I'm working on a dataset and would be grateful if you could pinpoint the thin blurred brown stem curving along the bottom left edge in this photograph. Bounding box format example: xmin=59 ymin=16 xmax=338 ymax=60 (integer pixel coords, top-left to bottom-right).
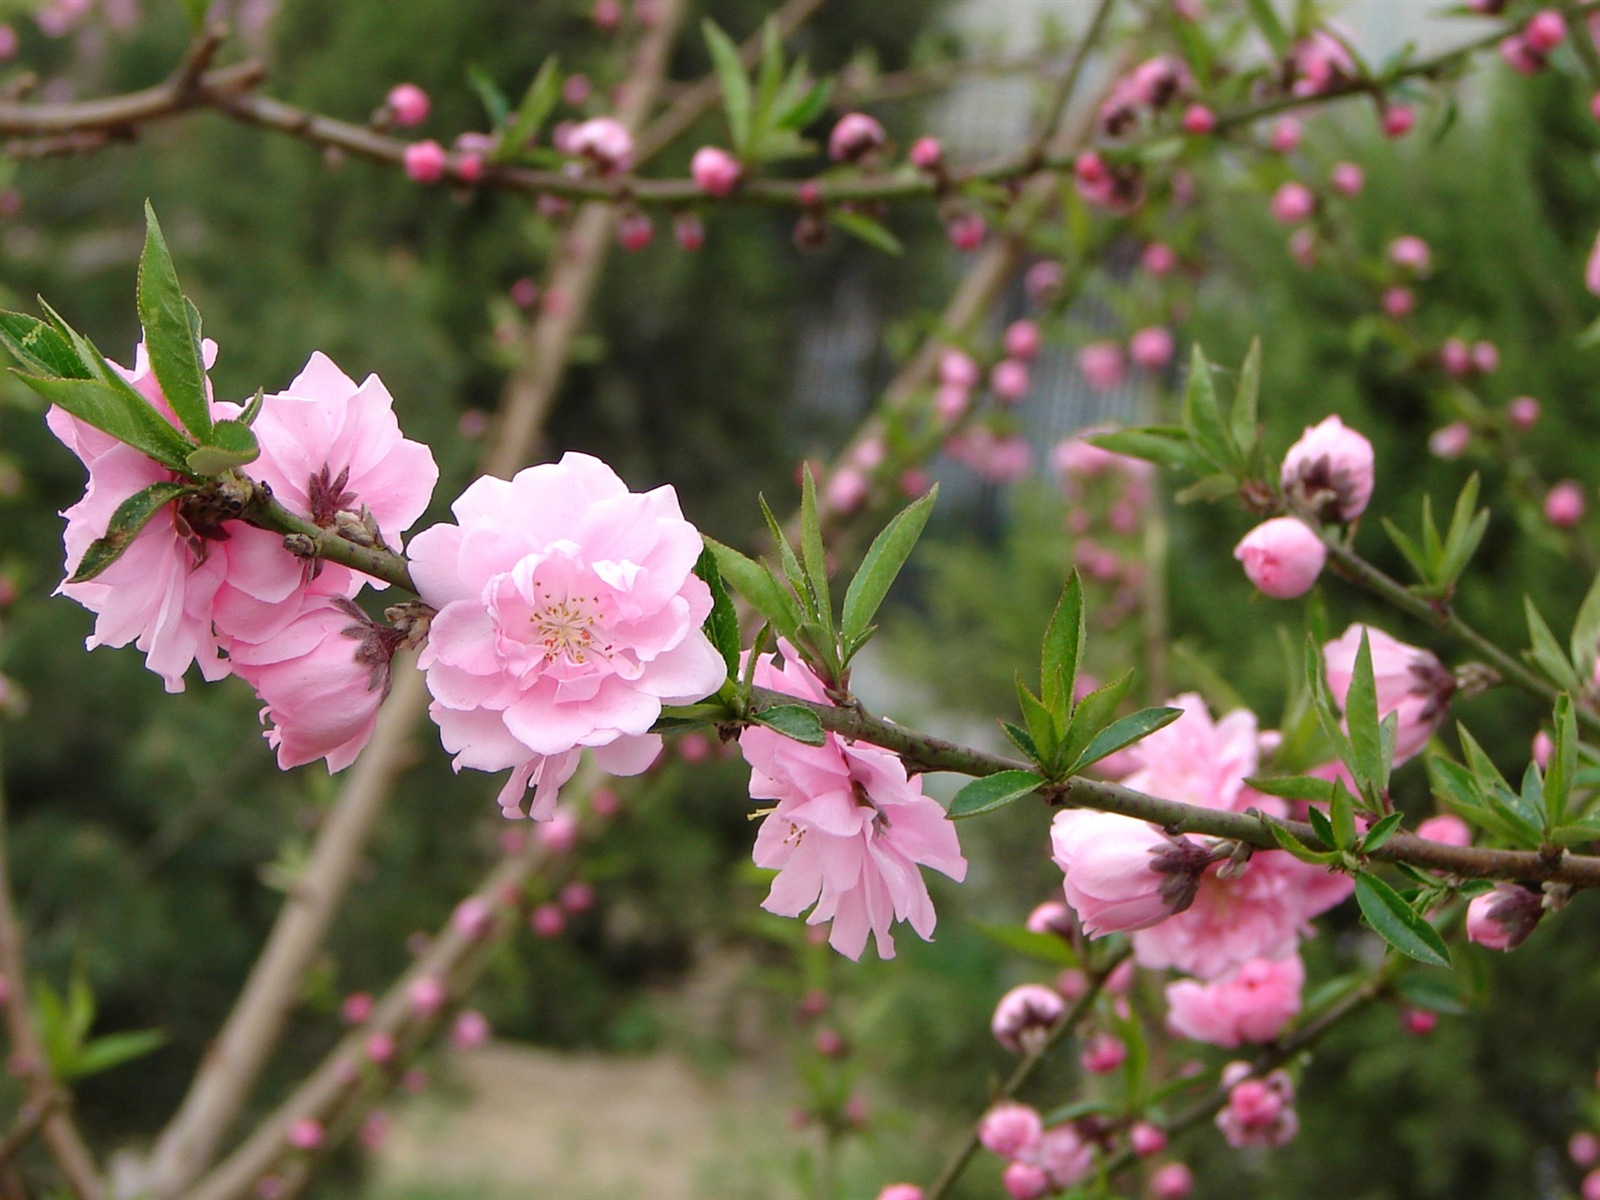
xmin=0 ymin=739 xmax=106 ymax=1200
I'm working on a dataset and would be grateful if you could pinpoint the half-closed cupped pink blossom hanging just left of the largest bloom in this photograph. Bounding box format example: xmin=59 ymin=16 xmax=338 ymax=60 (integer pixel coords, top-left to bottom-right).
xmin=229 ymin=595 xmax=402 ymax=771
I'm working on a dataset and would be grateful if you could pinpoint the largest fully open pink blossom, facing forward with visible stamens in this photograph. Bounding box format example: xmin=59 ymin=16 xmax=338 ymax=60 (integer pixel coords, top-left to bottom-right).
xmin=411 ymin=453 xmax=726 ymax=819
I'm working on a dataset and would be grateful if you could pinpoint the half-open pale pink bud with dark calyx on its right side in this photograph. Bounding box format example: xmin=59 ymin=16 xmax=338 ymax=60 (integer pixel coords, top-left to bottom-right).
xmin=1050 ymin=808 xmax=1211 ymax=938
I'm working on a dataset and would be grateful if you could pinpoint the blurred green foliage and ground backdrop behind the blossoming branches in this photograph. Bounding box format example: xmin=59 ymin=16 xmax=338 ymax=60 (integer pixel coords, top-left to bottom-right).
xmin=0 ymin=0 xmax=1600 ymax=1200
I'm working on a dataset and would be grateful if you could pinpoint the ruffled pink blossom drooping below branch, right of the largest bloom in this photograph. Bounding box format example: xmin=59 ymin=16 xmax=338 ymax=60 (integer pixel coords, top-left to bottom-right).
xmin=739 ymin=650 xmax=966 ymax=958
